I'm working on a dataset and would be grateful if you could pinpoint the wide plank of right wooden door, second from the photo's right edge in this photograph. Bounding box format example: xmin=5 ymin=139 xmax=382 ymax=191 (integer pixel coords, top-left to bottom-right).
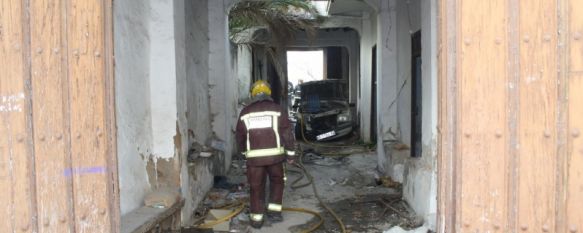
xmin=512 ymin=0 xmax=559 ymax=232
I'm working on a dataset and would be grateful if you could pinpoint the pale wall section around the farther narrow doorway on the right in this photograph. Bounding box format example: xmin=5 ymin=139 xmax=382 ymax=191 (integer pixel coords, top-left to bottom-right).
xmin=359 ymin=0 xmax=398 ymax=147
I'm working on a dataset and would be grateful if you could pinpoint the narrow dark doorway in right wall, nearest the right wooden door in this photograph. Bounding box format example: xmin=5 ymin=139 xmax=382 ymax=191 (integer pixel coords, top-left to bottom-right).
xmin=411 ymin=31 xmax=422 ymax=157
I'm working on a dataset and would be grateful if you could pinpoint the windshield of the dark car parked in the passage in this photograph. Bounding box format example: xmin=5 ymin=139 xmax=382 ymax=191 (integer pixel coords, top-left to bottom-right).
xmin=301 ymin=81 xmax=348 ymax=101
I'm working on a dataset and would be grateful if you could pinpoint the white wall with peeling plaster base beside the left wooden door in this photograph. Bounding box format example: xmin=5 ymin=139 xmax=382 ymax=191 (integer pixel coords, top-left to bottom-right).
xmin=114 ymin=0 xmax=185 ymax=215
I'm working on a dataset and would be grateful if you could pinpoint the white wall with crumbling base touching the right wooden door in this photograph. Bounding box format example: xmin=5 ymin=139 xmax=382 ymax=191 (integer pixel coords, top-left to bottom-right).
xmin=388 ymin=0 xmax=437 ymax=230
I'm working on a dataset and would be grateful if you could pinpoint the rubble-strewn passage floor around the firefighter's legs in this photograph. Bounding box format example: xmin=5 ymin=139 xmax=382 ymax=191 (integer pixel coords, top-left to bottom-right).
xmin=183 ymin=145 xmax=423 ymax=233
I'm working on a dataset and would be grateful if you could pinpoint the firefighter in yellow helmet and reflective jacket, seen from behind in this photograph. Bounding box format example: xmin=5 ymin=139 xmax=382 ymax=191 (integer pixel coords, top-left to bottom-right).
xmin=236 ymin=80 xmax=295 ymax=228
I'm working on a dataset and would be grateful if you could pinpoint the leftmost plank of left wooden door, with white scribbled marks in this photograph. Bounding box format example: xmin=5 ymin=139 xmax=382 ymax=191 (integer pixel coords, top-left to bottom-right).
xmin=0 ymin=0 xmax=37 ymax=232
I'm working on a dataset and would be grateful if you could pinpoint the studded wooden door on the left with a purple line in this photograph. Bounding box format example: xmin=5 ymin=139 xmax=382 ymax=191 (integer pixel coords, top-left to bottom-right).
xmin=0 ymin=0 xmax=119 ymax=233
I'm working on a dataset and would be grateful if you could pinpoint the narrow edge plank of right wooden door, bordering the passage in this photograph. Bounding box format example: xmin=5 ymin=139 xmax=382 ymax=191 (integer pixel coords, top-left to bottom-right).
xmin=437 ymin=0 xmax=459 ymax=232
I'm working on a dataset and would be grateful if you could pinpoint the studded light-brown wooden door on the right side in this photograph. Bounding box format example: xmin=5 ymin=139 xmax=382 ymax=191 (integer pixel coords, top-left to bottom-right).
xmin=438 ymin=0 xmax=583 ymax=232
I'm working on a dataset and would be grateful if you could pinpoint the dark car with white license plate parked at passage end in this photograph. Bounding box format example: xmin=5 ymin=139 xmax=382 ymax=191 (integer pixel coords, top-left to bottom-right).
xmin=294 ymin=80 xmax=354 ymax=141
